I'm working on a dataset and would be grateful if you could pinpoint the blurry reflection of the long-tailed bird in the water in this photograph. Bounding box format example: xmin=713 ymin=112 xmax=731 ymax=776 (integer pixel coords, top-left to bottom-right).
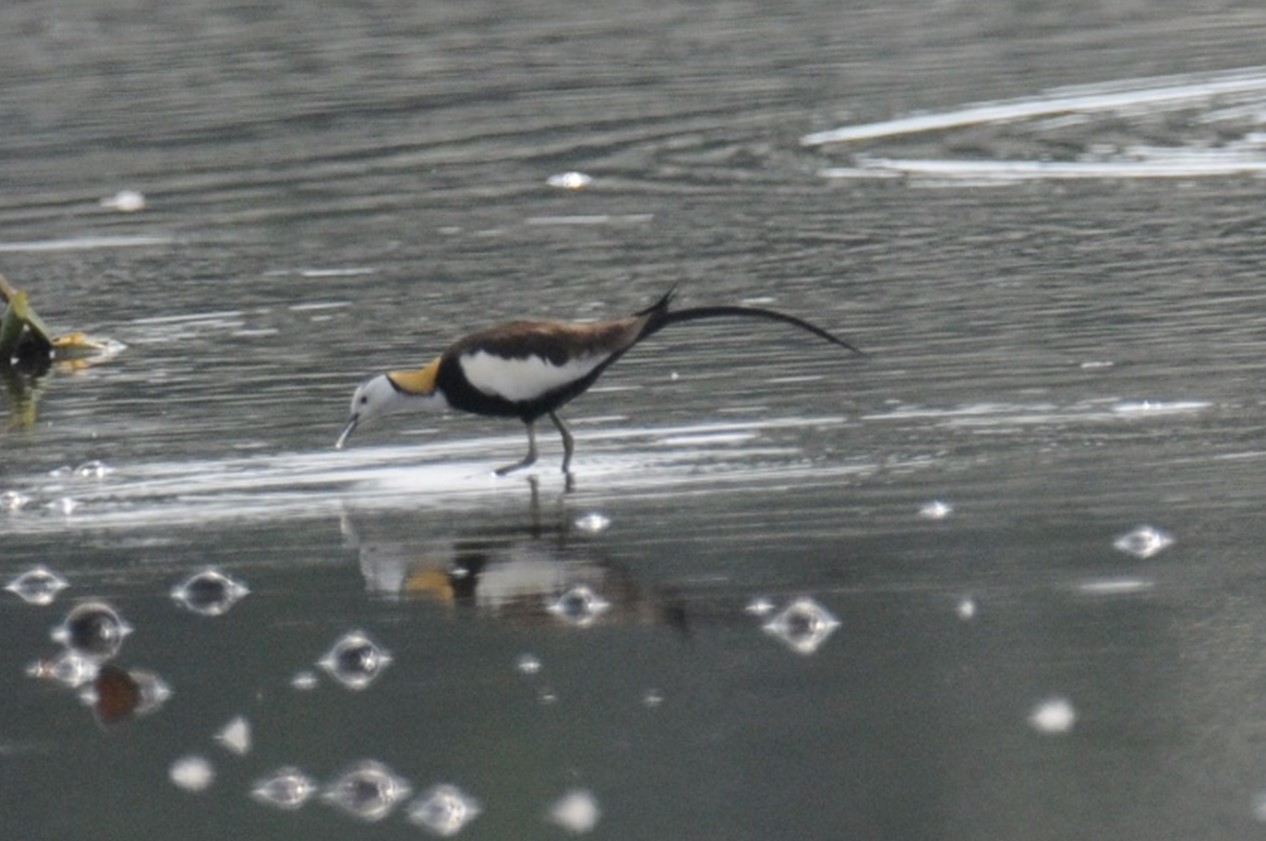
xmin=342 ymin=480 xmax=685 ymax=627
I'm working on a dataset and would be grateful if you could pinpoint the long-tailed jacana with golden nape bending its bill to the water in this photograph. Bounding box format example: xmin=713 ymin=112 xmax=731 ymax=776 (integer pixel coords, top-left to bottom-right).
xmin=334 ymin=290 xmax=861 ymax=476
